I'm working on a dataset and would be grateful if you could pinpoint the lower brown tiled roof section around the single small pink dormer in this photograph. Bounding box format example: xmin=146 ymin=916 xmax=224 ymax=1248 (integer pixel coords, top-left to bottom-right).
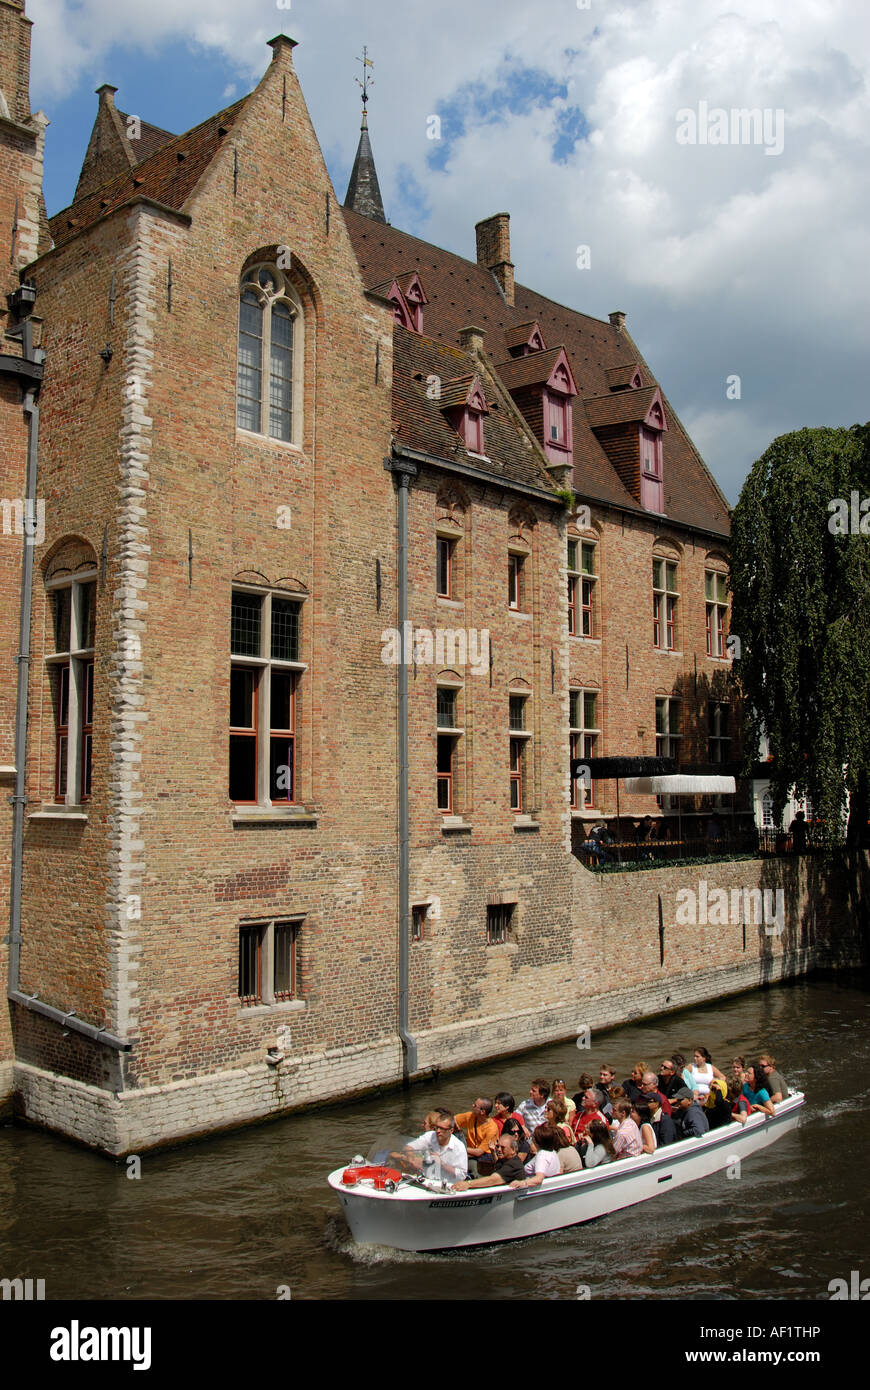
xmin=393 ymin=324 xmax=553 ymax=492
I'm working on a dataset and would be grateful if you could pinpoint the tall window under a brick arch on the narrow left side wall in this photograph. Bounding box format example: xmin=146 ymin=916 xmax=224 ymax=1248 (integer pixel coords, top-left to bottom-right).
xmin=46 ymin=569 xmax=97 ymax=806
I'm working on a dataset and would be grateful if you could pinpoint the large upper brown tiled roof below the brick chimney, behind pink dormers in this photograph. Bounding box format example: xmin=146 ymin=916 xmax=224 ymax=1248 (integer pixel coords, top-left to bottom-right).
xmin=345 ymin=209 xmax=730 ymax=537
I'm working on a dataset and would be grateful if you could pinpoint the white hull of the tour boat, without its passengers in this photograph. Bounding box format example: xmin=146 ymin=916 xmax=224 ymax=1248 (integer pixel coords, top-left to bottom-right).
xmin=329 ymin=1091 xmax=805 ymax=1251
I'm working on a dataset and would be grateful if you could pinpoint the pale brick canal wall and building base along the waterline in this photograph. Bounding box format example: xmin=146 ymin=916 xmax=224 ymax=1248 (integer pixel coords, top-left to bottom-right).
xmin=6 ymin=856 xmax=870 ymax=1155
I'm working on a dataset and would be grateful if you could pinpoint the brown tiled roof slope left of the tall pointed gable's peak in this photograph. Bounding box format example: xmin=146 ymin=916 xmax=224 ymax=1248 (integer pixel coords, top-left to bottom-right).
xmin=50 ymin=96 xmax=247 ymax=246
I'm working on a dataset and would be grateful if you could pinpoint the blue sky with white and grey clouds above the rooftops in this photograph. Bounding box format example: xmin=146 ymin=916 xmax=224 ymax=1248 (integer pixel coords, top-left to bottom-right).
xmin=28 ymin=0 xmax=870 ymax=502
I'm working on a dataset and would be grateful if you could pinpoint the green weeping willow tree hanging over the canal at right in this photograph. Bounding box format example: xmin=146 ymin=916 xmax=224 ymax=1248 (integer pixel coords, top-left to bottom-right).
xmin=731 ymin=425 xmax=870 ymax=842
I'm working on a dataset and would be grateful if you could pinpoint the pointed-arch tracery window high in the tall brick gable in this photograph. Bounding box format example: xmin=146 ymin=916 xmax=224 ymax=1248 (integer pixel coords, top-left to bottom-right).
xmin=236 ymin=265 xmax=304 ymax=446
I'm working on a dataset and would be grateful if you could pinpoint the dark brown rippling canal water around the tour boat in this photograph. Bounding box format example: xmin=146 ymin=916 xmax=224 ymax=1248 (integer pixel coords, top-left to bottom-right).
xmin=0 ymin=974 xmax=870 ymax=1300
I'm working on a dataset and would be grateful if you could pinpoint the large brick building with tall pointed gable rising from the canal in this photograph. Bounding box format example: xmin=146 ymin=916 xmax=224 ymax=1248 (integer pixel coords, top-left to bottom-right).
xmin=0 ymin=8 xmax=750 ymax=1152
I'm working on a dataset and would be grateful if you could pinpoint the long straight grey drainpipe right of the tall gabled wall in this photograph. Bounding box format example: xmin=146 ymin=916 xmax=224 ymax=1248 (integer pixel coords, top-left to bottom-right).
xmin=384 ymin=459 xmax=420 ymax=1086
